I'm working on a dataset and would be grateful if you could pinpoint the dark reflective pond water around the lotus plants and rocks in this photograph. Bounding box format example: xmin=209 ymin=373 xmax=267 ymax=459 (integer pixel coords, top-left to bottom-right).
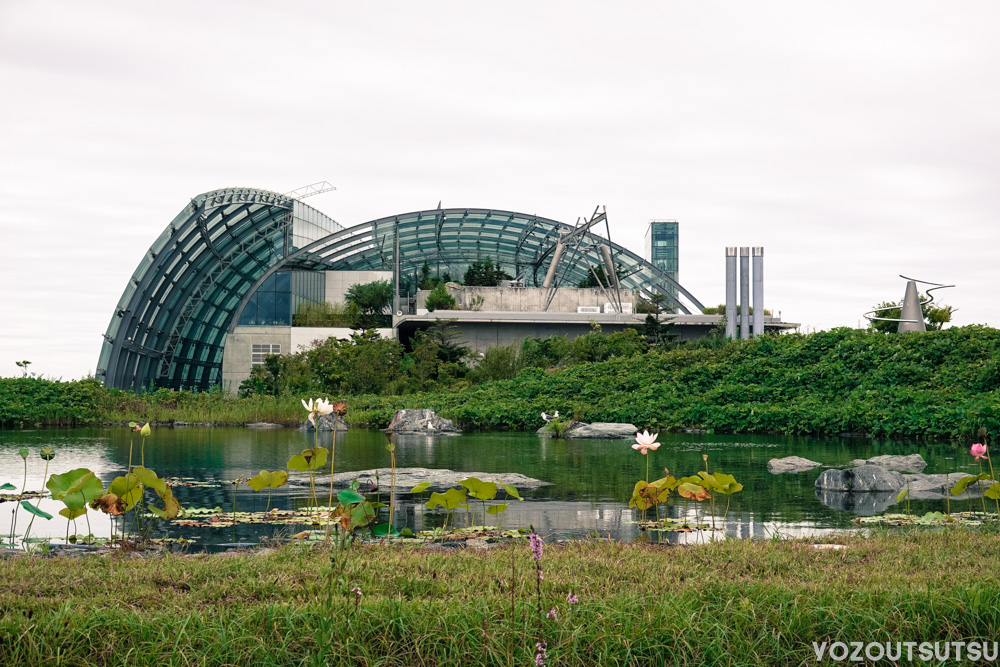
xmin=0 ymin=427 xmax=979 ymax=549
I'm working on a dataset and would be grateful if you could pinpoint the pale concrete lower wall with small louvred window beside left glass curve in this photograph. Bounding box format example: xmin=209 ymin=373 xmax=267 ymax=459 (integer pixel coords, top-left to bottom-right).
xmin=222 ymin=326 xmax=396 ymax=394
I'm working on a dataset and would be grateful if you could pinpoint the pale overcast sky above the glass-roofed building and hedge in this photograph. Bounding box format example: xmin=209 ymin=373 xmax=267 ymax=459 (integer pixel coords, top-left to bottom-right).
xmin=0 ymin=0 xmax=1000 ymax=379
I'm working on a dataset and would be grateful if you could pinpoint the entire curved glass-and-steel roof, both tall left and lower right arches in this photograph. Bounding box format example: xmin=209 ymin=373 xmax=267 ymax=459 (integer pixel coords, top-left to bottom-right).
xmin=97 ymin=188 xmax=702 ymax=391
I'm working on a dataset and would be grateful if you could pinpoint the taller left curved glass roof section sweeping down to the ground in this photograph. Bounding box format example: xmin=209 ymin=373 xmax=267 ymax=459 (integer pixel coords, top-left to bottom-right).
xmin=97 ymin=188 xmax=342 ymax=391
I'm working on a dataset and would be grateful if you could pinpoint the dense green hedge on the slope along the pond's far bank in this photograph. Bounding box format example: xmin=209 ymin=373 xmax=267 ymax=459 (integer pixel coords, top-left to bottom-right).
xmin=0 ymin=326 xmax=1000 ymax=437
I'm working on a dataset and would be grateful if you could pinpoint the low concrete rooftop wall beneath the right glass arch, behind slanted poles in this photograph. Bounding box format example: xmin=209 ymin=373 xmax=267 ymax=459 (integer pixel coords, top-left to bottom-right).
xmin=416 ymin=287 xmax=638 ymax=313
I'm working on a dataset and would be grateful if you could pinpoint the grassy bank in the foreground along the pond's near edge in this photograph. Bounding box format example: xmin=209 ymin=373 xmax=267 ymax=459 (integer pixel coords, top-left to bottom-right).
xmin=0 ymin=529 xmax=1000 ymax=666
